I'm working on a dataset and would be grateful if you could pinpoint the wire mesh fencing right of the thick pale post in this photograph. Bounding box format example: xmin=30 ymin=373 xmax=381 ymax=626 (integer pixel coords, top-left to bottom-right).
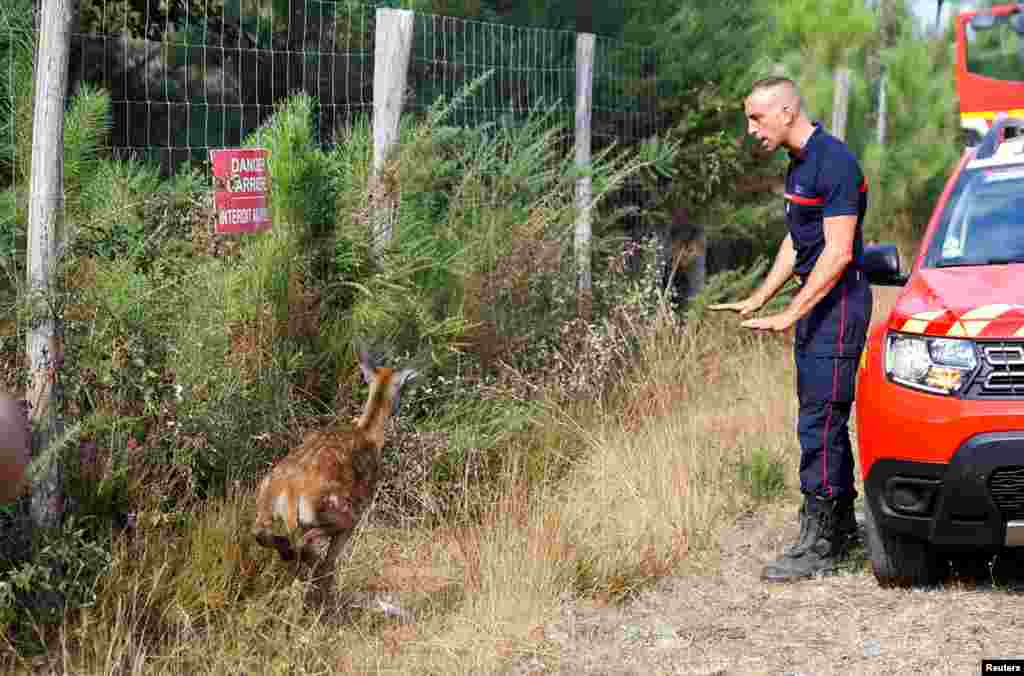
xmin=407 ymin=14 xmax=657 ymax=237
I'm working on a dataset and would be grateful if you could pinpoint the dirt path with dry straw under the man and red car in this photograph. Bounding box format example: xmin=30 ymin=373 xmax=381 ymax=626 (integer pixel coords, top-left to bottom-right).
xmin=512 ymin=505 xmax=1024 ymax=676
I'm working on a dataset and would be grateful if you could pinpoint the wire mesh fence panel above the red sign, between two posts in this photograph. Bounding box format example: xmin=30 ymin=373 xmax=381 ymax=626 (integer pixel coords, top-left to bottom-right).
xmin=71 ymin=0 xmax=374 ymax=170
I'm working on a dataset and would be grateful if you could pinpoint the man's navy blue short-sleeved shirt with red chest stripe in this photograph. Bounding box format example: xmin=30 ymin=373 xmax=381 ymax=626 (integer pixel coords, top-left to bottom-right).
xmin=785 ymin=123 xmax=867 ymax=277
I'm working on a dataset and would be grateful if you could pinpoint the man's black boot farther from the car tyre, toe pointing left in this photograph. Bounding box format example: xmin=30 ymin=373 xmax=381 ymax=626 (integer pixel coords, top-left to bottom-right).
xmin=761 ymin=496 xmax=843 ymax=582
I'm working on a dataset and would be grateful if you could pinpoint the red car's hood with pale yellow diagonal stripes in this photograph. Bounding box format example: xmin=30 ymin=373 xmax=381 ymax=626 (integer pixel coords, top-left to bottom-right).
xmin=889 ymin=264 xmax=1024 ymax=338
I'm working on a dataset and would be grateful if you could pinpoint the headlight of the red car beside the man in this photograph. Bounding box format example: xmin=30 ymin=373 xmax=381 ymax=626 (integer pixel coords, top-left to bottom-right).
xmin=886 ymin=333 xmax=978 ymax=394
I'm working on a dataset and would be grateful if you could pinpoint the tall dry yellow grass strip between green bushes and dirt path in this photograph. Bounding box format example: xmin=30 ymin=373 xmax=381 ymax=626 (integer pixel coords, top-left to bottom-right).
xmin=14 ymin=318 xmax=796 ymax=676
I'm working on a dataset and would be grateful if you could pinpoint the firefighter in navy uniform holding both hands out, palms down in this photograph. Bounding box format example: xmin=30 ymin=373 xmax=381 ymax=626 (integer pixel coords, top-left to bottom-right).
xmin=711 ymin=77 xmax=871 ymax=582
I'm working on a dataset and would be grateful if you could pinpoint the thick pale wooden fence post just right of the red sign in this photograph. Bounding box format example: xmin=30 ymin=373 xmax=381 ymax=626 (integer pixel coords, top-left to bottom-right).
xmin=370 ymin=8 xmax=414 ymax=257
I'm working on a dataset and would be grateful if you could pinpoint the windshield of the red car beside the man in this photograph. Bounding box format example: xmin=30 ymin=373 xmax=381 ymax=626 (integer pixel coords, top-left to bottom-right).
xmin=930 ymin=165 xmax=1024 ymax=267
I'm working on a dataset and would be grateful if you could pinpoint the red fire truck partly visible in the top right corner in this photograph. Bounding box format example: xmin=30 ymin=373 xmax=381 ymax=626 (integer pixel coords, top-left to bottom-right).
xmin=956 ymin=3 xmax=1024 ymax=145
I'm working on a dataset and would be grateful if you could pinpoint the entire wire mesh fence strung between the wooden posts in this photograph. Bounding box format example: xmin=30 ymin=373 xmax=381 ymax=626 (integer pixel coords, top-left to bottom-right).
xmin=0 ymin=0 xmax=657 ymax=229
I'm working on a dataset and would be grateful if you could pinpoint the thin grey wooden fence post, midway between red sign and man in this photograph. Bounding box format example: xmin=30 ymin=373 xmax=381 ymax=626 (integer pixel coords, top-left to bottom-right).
xmin=573 ymin=33 xmax=595 ymax=320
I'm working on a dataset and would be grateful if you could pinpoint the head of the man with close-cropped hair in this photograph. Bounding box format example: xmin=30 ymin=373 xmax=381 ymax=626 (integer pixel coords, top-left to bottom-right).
xmin=743 ymin=77 xmax=809 ymax=153
